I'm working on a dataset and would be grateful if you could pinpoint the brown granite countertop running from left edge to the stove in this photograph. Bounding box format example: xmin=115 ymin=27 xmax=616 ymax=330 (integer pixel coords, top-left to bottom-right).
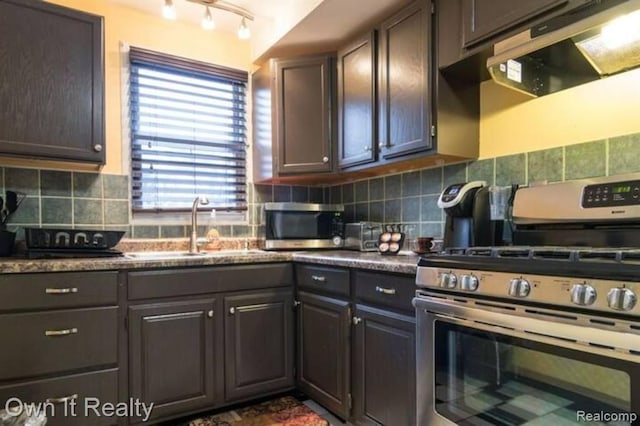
xmin=0 ymin=250 xmax=418 ymax=275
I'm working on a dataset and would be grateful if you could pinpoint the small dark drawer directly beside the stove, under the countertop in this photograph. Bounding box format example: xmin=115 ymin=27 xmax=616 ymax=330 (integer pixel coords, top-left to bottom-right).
xmin=354 ymin=271 xmax=416 ymax=311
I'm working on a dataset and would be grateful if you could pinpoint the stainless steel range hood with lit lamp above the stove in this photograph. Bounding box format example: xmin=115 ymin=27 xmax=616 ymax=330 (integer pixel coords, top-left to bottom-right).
xmin=487 ymin=0 xmax=640 ymax=96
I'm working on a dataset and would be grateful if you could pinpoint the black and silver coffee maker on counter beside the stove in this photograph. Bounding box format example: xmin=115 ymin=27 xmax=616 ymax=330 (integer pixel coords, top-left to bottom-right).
xmin=438 ymin=181 xmax=505 ymax=249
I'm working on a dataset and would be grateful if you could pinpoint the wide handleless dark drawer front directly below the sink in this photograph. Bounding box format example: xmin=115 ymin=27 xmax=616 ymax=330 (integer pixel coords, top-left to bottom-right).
xmin=128 ymin=263 xmax=293 ymax=300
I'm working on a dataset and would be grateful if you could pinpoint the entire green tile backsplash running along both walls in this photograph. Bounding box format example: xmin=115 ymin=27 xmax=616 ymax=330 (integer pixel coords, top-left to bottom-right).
xmin=0 ymin=130 xmax=640 ymax=243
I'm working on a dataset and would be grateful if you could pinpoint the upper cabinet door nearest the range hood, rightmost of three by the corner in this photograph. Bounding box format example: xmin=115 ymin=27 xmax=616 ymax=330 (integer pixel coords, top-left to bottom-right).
xmin=378 ymin=0 xmax=432 ymax=158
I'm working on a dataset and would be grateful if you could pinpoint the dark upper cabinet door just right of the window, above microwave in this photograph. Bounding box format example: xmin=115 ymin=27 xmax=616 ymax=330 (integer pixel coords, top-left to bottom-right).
xmin=275 ymin=56 xmax=333 ymax=174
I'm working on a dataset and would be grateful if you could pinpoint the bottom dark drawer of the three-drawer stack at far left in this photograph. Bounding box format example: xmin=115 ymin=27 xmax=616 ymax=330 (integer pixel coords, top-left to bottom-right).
xmin=0 ymin=369 xmax=118 ymax=426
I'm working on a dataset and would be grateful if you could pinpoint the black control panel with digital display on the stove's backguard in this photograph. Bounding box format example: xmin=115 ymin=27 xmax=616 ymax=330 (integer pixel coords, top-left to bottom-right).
xmin=582 ymin=180 xmax=640 ymax=208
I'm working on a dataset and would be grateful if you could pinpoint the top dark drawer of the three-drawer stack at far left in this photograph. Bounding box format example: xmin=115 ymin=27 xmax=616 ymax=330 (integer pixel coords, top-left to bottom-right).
xmin=0 ymin=271 xmax=118 ymax=311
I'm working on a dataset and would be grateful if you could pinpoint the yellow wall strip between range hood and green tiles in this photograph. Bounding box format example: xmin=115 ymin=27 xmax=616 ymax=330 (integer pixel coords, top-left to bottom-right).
xmin=480 ymin=69 xmax=640 ymax=158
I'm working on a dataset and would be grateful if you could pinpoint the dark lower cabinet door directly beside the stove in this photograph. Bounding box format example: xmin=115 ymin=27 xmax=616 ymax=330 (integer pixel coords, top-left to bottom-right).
xmin=353 ymin=305 xmax=416 ymax=426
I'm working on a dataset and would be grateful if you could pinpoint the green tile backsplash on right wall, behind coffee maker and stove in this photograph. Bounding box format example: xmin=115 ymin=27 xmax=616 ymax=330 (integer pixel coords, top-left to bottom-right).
xmin=327 ymin=134 xmax=640 ymax=236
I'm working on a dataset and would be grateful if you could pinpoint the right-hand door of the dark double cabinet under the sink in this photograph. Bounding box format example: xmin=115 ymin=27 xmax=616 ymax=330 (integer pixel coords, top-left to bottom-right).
xmin=224 ymin=290 xmax=294 ymax=401
